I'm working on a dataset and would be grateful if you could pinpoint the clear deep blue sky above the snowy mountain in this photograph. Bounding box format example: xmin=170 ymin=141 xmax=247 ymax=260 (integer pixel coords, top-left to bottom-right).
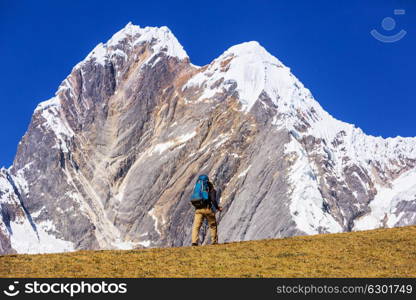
xmin=0 ymin=0 xmax=416 ymax=167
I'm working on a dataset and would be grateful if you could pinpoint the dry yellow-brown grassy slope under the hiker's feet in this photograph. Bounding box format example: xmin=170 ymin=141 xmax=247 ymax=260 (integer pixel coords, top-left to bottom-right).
xmin=0 ymin=226 xmax=416 ymax=277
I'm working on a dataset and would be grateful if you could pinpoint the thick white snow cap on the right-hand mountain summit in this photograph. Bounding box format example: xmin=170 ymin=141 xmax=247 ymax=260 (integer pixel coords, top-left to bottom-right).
xmin=187 ymin=41 xmax=292 ymax=111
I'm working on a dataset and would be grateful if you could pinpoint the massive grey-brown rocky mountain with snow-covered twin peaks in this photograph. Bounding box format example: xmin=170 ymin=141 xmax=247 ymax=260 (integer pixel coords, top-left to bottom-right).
xmin=0 ymin=24 xmax=416 ymax=253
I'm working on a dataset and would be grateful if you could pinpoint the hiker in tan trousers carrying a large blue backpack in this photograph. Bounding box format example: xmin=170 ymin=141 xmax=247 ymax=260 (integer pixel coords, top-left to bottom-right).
xmin=191 ymin=175 xmax=222 ymax=246
